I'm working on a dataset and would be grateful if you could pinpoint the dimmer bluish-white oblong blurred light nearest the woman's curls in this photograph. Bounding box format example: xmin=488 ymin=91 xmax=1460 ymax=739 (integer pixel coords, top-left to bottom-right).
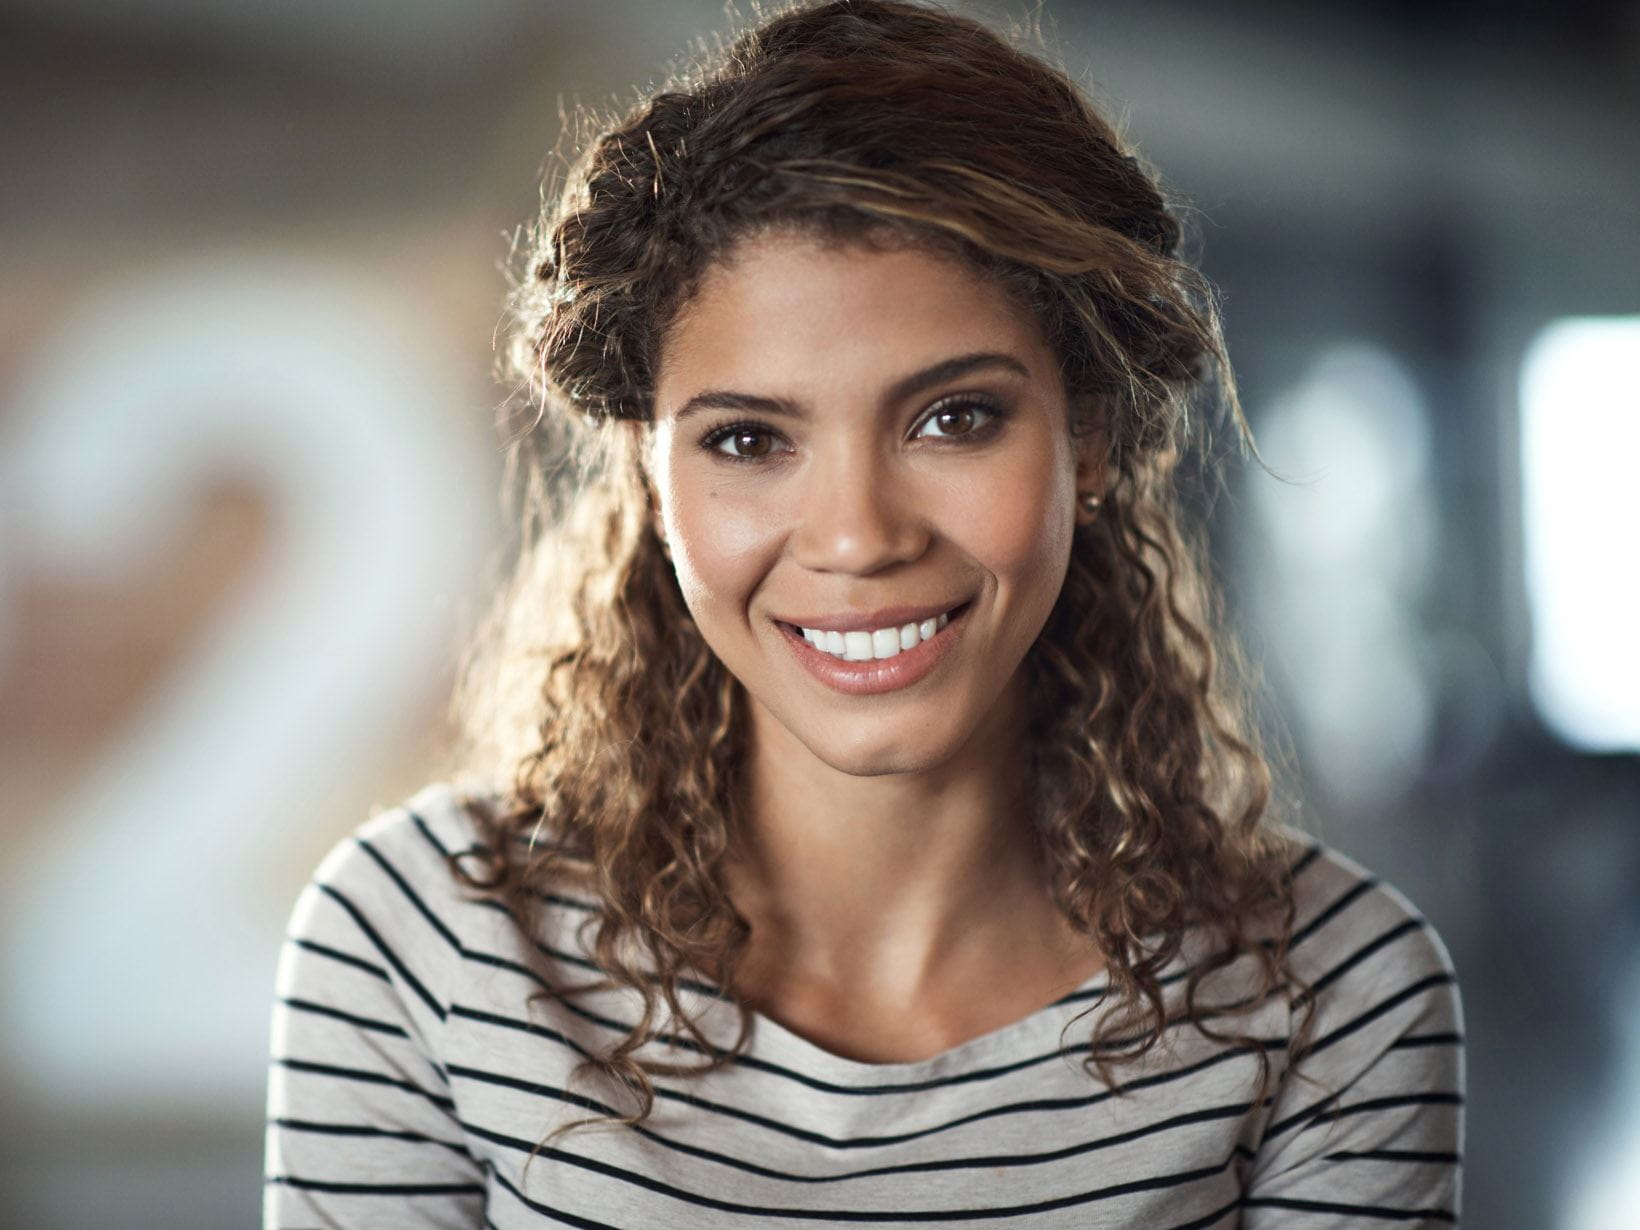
xmin=1251 ymin=343 xmax=1435 ymax=809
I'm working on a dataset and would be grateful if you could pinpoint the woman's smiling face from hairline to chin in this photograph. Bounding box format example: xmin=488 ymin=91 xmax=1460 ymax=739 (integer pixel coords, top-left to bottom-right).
xmin=646 ymin=236 xmax=1094 ymax=776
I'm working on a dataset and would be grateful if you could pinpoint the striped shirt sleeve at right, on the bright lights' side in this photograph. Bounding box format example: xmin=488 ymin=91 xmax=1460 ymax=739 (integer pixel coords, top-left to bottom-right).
xmin=1241 ymin=859 xmax=1463 ymax=1230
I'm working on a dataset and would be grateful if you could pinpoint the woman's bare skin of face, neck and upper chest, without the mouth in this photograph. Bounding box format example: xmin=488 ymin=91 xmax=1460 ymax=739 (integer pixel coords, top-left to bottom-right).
xmin=640 ymin=235 xmax=1102 ymax=1063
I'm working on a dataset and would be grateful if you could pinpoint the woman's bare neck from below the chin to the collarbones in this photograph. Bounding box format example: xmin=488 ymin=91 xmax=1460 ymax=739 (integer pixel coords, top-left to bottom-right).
xmin=728 ymin=678 xmax=1063 ymax=992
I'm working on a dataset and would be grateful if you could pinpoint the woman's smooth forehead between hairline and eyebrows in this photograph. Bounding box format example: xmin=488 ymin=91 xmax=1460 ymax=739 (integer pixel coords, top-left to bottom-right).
xmin=656 ymin=233 xmax=1056 ymax=405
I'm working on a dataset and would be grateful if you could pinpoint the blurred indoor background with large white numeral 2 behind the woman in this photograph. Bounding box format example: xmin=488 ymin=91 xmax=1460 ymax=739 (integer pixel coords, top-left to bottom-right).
xmin=0 ymin=0 xmax=1640 ymax=1230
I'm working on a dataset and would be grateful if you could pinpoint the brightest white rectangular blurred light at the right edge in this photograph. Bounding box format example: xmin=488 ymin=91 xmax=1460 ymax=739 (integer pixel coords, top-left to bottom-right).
xmin=1520 ymin=317 xmax=1640 ymax=751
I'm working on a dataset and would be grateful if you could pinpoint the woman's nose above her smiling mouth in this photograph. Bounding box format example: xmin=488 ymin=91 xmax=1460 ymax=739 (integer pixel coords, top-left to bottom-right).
xmin=790 ymin=448 xmax=932 ymax=576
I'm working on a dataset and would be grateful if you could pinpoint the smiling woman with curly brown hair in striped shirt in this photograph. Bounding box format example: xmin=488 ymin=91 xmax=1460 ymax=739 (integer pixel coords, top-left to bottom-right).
xmin=267 ymin=0 xmax=1461 ymax=1227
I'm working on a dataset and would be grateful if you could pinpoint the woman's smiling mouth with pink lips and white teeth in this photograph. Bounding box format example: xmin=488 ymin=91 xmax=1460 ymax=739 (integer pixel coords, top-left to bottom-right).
xmin=776 ymin=602 xmax=968 ymax=695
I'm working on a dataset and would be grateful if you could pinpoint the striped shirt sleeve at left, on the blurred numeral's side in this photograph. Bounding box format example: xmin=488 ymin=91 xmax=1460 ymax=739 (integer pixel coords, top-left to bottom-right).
xmin=262 ymin=812 xmax=484 ymax=1230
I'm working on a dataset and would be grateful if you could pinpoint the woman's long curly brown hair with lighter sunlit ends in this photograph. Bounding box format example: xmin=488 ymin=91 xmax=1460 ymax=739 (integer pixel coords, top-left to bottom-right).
xmin=458 ymin=0 xmax=1294 ymax=1122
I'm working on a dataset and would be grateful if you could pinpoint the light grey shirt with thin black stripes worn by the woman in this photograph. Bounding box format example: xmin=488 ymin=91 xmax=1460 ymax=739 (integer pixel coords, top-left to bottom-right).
xmin=264 ymin=787 xmax=1463 ymax=1230
